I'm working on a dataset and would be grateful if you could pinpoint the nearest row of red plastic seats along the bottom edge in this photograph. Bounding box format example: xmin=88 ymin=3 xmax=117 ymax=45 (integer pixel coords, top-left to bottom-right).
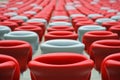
xmin=0 ymin=52 xmax=120 ymax=80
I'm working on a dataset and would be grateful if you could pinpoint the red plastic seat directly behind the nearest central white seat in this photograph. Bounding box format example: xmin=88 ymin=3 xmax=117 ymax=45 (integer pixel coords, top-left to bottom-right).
xmin=45 ymin=31 xmax=78 ymax=41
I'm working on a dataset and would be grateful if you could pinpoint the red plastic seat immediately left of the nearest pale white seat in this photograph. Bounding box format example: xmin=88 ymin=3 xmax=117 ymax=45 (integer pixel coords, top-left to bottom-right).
xmin=0 ymin=40 xmax=32 ymax=72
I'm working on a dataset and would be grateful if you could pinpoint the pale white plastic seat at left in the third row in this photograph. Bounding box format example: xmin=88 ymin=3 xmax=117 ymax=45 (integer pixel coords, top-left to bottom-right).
xmin=4 ymin=31 xmax=39 ymax=53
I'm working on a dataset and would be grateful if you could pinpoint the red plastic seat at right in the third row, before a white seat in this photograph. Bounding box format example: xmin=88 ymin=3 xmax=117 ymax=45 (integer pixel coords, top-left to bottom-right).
xmin=82 ymin=31 xmax=118 ymax=54
